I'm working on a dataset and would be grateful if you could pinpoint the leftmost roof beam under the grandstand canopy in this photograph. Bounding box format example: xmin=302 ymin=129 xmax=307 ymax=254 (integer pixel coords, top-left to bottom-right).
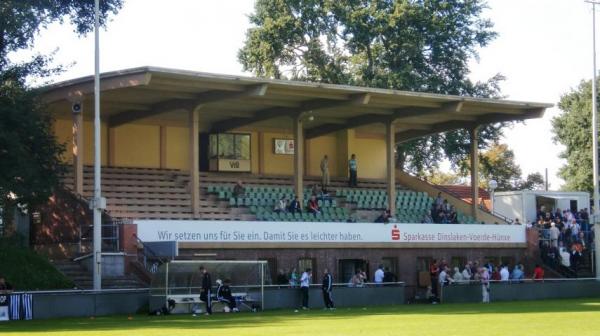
xmin=108 ymin=84 xmax=267 ymax=127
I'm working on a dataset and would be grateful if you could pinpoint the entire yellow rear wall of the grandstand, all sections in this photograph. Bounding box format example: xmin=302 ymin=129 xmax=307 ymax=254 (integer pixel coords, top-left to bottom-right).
xmin=54 ymin=119 xmax=386 ymax=179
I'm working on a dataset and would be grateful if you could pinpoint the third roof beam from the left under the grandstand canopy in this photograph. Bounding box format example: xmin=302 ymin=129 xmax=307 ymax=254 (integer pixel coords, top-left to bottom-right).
xmin=305 ymin=102 xmax=463 ymax=139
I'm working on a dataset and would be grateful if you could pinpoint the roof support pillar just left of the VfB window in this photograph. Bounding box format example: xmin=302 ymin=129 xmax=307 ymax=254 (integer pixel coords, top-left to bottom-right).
xmin=188 ymin=110 xmax=200 ymax=218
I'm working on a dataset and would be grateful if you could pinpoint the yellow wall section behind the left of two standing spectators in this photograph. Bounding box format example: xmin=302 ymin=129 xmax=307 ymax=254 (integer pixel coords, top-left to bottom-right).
xmin=305 ymin=135 xmax=339 ymax=176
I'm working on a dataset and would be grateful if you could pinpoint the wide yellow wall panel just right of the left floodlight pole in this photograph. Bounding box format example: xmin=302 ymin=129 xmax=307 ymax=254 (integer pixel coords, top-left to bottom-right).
xmin=115 ymin=124 xmax=160 ymax=168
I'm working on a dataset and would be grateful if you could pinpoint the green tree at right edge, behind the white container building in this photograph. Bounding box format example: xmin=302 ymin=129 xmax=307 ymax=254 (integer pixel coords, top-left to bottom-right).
xmin=552 ymin=80 xmax=594 ymax=192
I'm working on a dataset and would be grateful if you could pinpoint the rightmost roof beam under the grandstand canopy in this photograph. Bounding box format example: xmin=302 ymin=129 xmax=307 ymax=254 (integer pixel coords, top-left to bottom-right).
xmin=396 ymin=108 xmax=545 ymax=142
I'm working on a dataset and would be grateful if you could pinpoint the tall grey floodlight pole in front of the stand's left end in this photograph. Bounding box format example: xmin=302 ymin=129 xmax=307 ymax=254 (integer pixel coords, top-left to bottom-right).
xmin=91 ymin=0 xmax=104 ymax=291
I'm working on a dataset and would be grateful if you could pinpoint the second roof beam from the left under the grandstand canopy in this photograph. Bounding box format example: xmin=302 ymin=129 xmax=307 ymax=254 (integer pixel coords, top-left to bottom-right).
xmin=211 ymin=93 xmax=371 ymax=133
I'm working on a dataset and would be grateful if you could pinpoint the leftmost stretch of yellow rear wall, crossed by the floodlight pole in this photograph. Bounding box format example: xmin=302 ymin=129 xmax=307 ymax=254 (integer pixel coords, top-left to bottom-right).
xmin=54 ymin=119 xmax=108 ymax=165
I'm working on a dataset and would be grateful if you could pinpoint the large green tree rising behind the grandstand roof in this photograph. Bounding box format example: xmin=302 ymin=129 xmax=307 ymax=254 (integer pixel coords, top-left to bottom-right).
xmin=239 ymin=0 xmax=504 ymax=175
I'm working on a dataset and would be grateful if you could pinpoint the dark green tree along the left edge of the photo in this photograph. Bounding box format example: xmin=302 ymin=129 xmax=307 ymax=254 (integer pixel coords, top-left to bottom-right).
xmin=0 ymin=0 xmax=122 ymax=234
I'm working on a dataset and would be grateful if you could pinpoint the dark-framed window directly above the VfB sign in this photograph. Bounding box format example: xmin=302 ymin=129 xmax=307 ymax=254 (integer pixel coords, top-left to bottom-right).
xmin=209 ymin=133 xmax=250 ymax=160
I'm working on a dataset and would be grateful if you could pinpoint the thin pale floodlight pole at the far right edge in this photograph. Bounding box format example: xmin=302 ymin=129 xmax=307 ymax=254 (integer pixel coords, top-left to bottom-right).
xmin=585 ymin=0 xmax=600 ymax=280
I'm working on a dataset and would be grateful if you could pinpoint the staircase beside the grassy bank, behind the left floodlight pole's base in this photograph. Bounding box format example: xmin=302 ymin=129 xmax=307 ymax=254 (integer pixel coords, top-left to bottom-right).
xmin=52 ymin=260 xmax=147 ymax=289
